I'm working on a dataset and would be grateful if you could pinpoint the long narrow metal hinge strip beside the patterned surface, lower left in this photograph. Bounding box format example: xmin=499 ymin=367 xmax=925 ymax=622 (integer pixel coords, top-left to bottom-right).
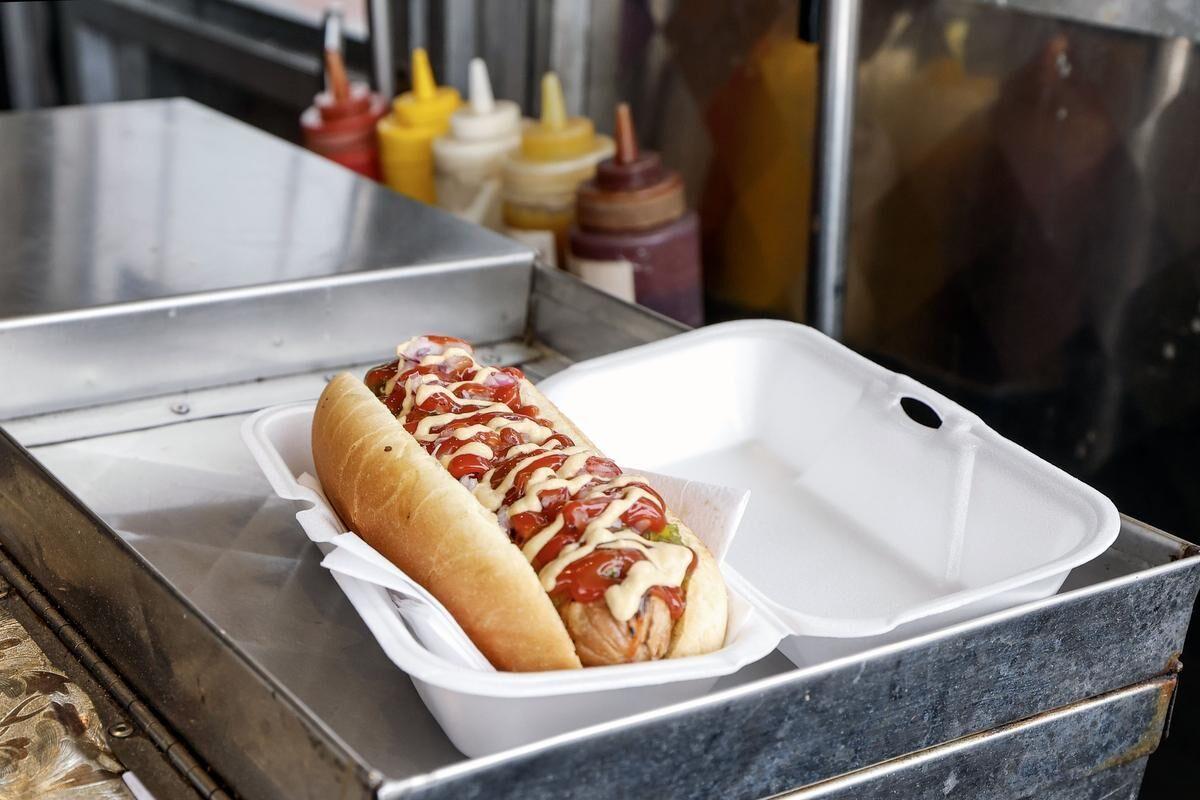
xmin=0 ymin=546 xmax=229 ymax=800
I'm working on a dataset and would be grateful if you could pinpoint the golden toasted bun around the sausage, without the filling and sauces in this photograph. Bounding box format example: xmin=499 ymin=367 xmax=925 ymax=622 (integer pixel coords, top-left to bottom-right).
xmin=312 ymin=373 xmax=727 ymax=672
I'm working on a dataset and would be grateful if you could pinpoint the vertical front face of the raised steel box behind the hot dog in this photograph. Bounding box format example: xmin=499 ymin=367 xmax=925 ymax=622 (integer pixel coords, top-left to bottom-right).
xmin=0 ymin=253 xmax=533 ymax=419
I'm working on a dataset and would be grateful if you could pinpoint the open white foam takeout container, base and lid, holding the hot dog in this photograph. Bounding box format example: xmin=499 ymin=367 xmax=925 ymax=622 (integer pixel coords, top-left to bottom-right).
xmin=244 ymin=320 xmax=1120 ymax=756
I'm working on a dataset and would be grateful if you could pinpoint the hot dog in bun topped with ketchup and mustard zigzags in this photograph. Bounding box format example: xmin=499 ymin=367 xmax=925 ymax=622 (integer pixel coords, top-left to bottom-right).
xmin=312 ymin=336 xmax=727 ymax=672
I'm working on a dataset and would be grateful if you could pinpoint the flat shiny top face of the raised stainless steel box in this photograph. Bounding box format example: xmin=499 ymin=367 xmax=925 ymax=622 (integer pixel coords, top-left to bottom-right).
xmin=0 ymin=98 xmax=528 ymax=320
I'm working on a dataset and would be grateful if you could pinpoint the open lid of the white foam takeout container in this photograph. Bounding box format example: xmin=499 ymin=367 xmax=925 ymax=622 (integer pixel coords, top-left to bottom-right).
xmin=540 ymin=320 xmax=1120 ymax=638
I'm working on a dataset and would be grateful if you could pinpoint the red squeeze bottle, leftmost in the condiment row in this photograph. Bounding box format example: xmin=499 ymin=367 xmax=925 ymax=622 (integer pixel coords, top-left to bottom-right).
xmin=300 ymin=14 xmax=388 ymax=181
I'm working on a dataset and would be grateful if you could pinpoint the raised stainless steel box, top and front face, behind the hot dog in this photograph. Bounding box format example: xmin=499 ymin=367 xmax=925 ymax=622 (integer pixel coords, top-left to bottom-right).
xmin=0 ymin=100 xmax=532 ymax=419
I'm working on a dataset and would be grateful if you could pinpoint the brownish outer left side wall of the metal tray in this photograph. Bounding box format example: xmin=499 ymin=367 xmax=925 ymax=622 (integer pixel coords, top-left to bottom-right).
xmin=0 ymin=429 xmax=382 ymax=798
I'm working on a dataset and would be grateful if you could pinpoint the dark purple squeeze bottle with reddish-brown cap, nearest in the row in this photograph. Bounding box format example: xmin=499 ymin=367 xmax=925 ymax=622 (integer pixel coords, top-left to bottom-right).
xmin=568 ymin=103 xmax=704 ymax=325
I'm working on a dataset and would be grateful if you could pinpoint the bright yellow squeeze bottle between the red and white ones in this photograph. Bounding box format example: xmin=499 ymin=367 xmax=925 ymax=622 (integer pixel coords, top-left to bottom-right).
xmin=376 ymin=47 xmax=462 ymax=204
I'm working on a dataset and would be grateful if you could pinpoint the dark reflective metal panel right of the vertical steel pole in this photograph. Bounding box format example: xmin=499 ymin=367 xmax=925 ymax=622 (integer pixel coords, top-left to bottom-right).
xmin=846 ymin=2 xmax=1200 ymax=482
